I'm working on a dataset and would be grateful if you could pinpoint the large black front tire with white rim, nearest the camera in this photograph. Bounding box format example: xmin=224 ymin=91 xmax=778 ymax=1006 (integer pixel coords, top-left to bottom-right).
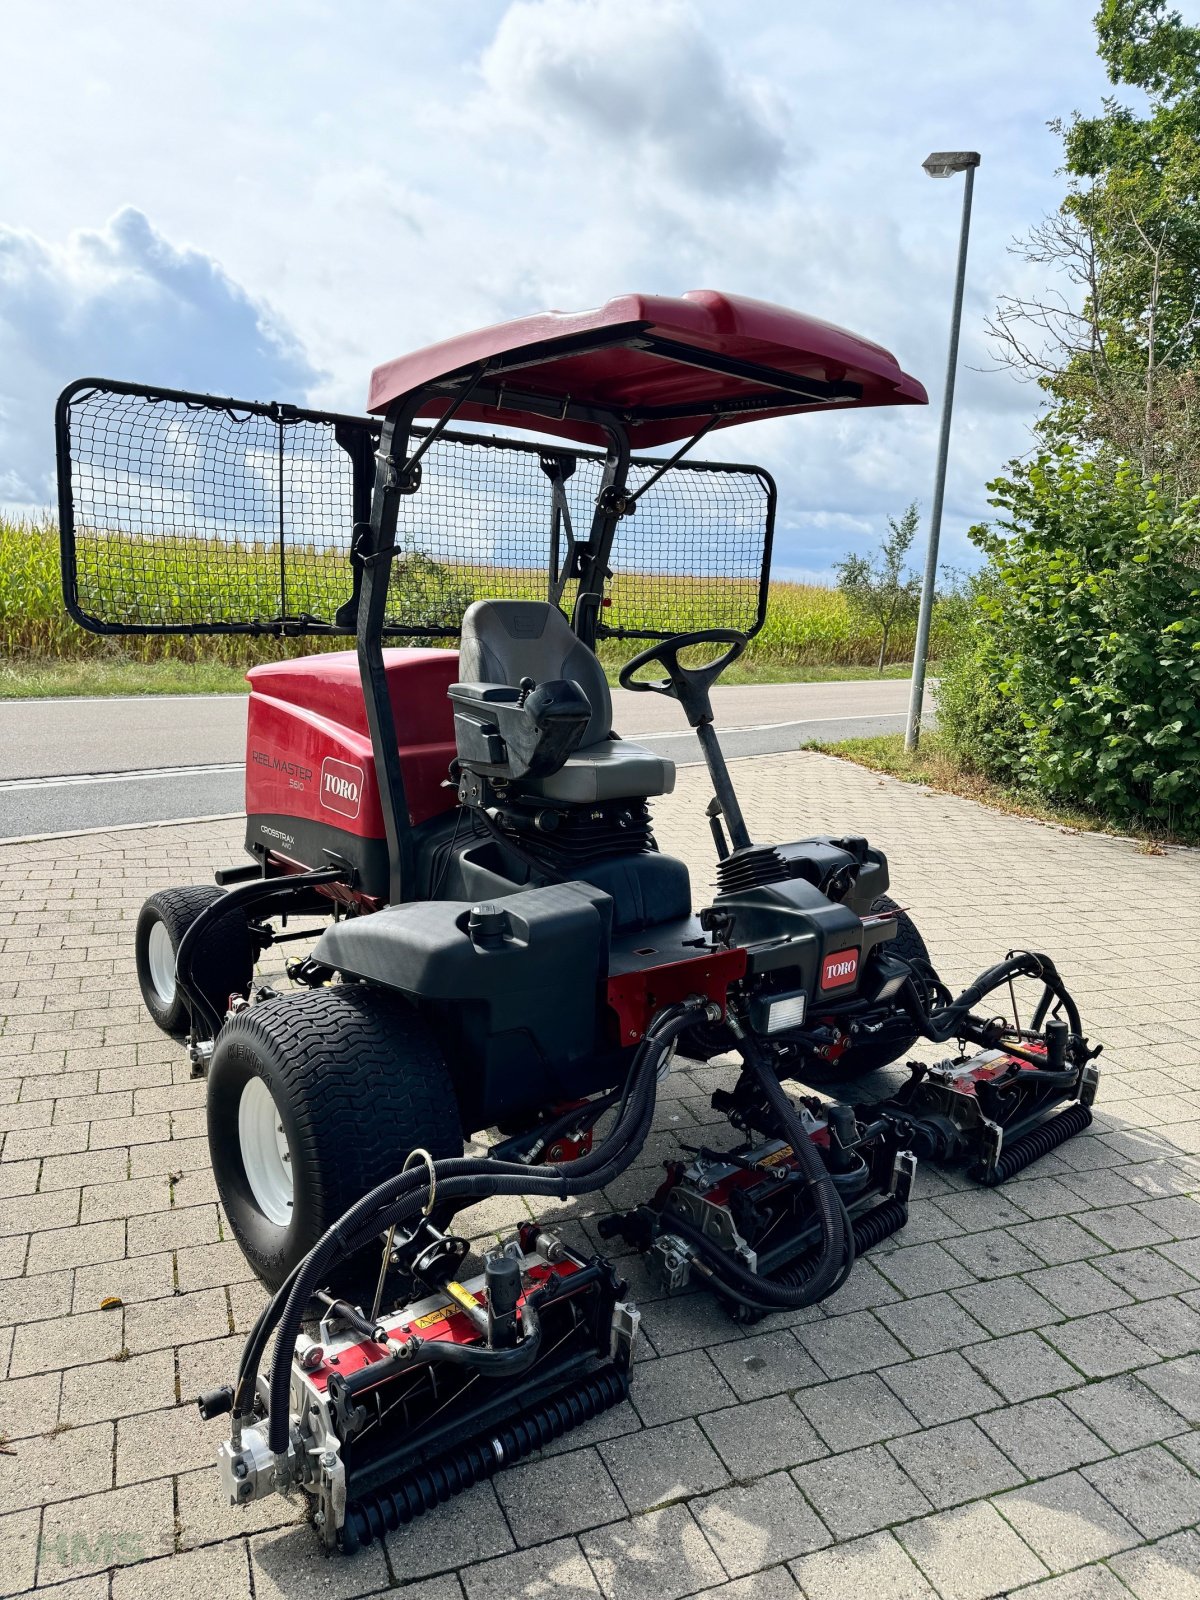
xmin=208 ymin=984 xmax=462 ymax=1301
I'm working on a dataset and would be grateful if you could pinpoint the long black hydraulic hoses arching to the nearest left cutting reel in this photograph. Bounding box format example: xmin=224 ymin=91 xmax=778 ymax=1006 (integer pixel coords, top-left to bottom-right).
xmin=259 ymin=998 xmax=700 ymax=1456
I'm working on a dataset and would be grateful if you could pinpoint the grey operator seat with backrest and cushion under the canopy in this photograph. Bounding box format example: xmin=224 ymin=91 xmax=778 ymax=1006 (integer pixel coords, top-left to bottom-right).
xmin=459 ymin=600 xmax=675 ymax=805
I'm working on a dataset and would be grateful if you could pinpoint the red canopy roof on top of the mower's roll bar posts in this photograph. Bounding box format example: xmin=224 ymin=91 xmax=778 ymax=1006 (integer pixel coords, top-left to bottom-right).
xmin=368 ymin=290 xmax=926 ymax=448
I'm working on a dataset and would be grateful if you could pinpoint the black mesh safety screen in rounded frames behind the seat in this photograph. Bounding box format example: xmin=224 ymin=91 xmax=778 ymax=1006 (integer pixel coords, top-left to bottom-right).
xmin=58 ymin=381 xmax=774 ymax=638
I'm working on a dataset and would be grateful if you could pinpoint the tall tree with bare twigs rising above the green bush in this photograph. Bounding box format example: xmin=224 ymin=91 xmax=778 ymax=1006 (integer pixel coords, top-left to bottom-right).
xmin=989 ymin=0 xmax=1200 ymax=504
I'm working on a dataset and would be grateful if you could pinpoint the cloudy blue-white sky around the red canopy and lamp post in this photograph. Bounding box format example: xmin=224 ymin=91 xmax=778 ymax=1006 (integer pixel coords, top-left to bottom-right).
xmin=0 ymin=0 xmax=1152 ymax=576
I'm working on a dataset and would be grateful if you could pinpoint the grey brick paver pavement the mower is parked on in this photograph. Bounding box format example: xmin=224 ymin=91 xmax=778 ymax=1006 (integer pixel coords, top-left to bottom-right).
xmin=0 ymin=754 xmax=1200 ymax=1600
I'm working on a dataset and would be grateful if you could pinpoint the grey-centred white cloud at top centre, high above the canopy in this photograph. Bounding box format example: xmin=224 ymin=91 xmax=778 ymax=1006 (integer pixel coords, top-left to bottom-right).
xmin=480 ymin=0 xmax=786 ymax=192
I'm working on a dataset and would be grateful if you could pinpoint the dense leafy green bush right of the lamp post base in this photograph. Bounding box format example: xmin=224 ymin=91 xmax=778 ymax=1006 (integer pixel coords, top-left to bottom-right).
xmin=938 ymin=445 xmax=1200 ymax=835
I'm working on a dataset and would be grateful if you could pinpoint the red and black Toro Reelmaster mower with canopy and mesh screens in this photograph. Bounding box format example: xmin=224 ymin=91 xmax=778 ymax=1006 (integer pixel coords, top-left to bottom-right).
xmin=58 ymin=293 xmax=1094 ymax=1549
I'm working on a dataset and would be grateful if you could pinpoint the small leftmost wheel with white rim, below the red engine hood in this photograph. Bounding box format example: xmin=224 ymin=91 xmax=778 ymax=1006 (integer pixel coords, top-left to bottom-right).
xmin=134 ymin=883 xmax=254 ymax=1035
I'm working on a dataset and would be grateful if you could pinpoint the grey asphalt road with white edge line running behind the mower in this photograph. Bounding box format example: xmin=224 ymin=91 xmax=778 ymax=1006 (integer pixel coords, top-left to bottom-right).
xmin=0 ymin=680 xmax=928 ymax=838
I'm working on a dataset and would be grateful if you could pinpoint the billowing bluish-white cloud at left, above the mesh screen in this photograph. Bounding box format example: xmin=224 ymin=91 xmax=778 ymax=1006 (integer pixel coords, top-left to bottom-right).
xmin=0 ymin=206 xmax=320 ymax=507
